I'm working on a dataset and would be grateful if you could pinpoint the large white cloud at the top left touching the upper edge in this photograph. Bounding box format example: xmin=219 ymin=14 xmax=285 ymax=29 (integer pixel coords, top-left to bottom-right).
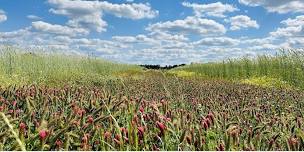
xmin=48 ymin=0 xmax=158 ymax=32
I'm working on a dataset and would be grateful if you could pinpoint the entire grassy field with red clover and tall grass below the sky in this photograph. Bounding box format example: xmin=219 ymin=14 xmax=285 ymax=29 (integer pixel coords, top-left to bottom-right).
xmin=0 ymin=48 xmax=304 ymax=151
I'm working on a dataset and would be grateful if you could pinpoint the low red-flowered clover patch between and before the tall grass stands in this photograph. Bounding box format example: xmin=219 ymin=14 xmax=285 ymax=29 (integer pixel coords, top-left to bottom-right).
xmin=0 ymin=75 xmax=304 ymax=150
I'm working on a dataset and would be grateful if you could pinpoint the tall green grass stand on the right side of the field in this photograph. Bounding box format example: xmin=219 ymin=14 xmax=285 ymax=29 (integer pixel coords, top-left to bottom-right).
xmin=174 ymin=50 xmax=304 ymax=89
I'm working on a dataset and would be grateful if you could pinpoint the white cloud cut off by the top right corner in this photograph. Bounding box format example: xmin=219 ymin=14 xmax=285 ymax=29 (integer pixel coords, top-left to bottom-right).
xmin=239 ymin=0 xmax=304 ymax=14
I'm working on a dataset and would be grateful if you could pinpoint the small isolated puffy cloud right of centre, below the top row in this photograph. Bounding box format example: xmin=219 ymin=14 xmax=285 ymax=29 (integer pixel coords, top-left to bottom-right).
xmin=225 ymin=15 xmax=260 ymax=31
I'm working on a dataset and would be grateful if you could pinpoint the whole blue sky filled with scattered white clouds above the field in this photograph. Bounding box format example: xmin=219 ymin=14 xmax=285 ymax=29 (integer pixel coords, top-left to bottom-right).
xmin=0 ymin=0 xmax=304 ymax=65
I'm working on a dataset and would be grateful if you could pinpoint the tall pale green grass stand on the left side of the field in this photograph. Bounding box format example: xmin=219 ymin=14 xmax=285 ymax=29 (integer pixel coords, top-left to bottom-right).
xmin=0 ymin=47 xmax=141 ymax=86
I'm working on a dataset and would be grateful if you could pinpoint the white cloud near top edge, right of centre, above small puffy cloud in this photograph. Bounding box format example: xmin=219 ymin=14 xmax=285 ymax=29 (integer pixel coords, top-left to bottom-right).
xmin=182 ymin=2 xmax=238 ymax=17
